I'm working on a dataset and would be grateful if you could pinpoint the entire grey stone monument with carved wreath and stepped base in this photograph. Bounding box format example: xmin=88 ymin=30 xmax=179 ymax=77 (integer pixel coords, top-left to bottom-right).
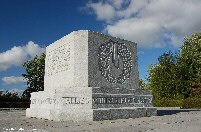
xmin=26 ymin=30 xmax=156 ymax=121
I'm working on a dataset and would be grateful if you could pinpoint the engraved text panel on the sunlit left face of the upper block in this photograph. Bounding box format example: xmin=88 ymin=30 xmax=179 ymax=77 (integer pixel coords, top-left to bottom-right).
xmin=46 ymin=44 xmax=70 ymax=76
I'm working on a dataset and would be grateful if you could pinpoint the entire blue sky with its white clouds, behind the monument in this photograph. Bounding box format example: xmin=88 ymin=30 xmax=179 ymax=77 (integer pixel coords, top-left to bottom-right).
xmin=0 ymin=0 xmax=201 ymax=91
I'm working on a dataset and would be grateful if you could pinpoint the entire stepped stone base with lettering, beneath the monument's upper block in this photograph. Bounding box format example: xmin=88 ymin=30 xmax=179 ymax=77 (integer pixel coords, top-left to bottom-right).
xmin=26 ymin=87 xmax=156 ymax=121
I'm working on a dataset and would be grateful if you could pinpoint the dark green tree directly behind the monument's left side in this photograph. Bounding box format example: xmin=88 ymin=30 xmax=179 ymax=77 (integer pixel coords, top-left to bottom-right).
xmin=22 ymin=53 xmax=45 ymax=97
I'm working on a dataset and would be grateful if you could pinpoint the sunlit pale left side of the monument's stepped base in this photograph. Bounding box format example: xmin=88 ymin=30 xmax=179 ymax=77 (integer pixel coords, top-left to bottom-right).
xmin=26 ymin=87 xmax=93 ymax=121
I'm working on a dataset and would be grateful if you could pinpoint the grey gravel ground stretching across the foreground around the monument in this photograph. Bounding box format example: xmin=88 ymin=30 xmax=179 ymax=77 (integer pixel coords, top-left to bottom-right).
xmin=0 ymin=109 xmax=201 ymax=132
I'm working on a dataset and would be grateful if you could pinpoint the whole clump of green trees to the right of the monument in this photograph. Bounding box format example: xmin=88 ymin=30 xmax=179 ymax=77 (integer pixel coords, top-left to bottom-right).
xmin=148 ymin=33 xmax=201 ymax=99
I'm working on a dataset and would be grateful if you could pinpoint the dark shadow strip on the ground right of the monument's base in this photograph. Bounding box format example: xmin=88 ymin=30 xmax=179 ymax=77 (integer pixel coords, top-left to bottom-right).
xmin=157 ymin=109 xmax=200 ymax=116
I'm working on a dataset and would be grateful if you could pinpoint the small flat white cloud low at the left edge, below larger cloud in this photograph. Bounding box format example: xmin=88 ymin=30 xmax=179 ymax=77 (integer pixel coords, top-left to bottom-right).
xmin=2 ymin=76 xmax=26 ymax=84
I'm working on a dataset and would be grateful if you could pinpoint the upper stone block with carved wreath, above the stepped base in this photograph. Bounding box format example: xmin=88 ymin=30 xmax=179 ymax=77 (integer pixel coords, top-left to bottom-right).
xmin=45 ymin=30 xmax=139 ymax=91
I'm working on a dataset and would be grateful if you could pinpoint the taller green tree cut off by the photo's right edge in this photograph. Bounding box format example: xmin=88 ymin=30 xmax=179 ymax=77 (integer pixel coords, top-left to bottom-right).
xmin=179 ymin=33 xmax=201 ymax=88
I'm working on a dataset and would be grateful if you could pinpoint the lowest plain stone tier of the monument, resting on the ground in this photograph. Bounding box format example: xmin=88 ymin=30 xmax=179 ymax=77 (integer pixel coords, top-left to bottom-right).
xmin=26 ymin=107 xmax=157 ymax=122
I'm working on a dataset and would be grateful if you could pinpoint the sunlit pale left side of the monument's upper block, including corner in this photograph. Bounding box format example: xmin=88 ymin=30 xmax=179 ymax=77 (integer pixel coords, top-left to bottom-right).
xmin=44 ymin=31 xmax=88 ymax=91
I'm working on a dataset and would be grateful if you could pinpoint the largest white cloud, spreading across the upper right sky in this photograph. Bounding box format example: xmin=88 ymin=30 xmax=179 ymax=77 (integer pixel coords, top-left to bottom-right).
xmin=87 ymin=0 xmax=201 ymax=47
